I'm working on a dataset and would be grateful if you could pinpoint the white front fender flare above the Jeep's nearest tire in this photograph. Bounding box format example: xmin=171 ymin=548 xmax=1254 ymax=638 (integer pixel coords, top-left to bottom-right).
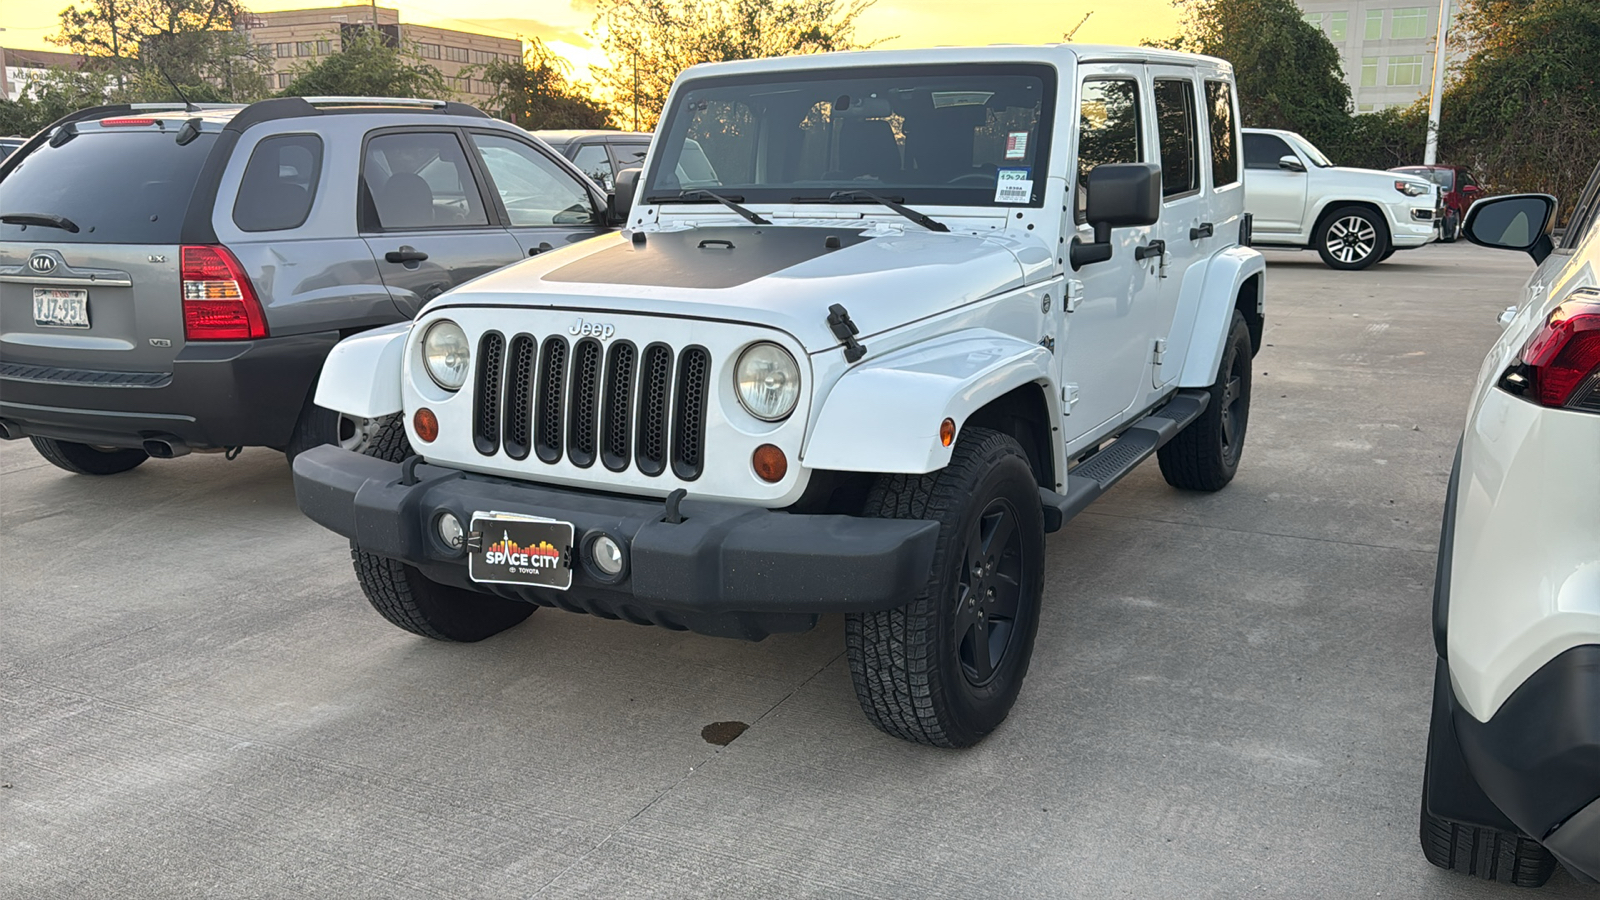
xmin=802 ymin=328 xmax=1051 ymax=474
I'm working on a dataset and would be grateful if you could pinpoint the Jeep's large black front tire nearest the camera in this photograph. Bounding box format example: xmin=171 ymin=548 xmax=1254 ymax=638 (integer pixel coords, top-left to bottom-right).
xmin=845 ymin=428 xmax=1045 ymax=748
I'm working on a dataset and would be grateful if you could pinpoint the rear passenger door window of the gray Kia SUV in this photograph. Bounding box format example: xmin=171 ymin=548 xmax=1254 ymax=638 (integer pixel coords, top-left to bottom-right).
xmin=362 ymin=131 xmax=490 ymax=231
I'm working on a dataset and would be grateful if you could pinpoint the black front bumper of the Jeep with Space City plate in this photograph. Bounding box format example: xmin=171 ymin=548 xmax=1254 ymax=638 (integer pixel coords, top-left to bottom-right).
xmin=294 ymin=447 xmax=939 ymax=639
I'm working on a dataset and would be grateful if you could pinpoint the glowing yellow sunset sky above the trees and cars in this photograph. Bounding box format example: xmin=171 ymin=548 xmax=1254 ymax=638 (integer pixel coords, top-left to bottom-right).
xmin=0 ymin=0 xmax=1178 ymax=89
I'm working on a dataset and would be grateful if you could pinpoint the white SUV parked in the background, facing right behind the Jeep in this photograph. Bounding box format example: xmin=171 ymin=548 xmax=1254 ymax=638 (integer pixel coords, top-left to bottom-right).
xmin=1245 ymin=128 xmax=1443 ymax=269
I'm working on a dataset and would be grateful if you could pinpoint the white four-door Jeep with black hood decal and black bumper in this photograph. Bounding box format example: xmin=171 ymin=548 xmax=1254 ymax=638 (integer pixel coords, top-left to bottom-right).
xmin=294 ymin=45 xmax=1266 ymax=746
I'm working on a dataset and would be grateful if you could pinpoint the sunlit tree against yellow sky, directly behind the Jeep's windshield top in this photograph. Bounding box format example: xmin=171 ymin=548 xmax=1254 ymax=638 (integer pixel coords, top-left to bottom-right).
xmin=594 ymin=0 xmax=883 ymax=131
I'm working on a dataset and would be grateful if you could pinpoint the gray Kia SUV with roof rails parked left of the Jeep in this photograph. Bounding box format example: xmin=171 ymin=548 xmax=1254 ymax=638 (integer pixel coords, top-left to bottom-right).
xmin=0 ymin=98 xmax=614 ymax=474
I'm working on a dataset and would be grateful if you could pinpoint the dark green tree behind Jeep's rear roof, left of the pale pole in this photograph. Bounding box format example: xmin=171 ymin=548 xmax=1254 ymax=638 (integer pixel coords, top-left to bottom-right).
xmin=1157 ymin=0 xmax=1350 ymax=146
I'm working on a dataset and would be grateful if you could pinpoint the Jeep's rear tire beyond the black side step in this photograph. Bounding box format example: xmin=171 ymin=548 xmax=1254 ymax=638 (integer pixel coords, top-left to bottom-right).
xmin=1155 ymin=309 xmax=1251 ymax=492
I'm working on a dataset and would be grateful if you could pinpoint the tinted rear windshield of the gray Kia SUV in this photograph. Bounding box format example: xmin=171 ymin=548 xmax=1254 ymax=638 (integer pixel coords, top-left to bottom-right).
xmin=0 ymin=125 xmax=216 ymax=243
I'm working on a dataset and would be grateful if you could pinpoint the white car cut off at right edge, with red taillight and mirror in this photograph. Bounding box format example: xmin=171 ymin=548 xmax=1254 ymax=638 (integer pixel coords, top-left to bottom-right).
xmin=1421 ymin=168 xmax=1600 ymax=886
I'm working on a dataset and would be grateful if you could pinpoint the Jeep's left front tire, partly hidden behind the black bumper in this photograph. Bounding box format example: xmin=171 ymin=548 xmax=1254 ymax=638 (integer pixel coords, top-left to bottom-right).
xmin=350 ymin=416 xmax=538 ymax=642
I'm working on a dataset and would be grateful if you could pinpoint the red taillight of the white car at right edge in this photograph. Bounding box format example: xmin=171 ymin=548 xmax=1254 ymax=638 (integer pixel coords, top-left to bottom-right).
xmin=1501 ymin=288 xmax=1600 ymax=412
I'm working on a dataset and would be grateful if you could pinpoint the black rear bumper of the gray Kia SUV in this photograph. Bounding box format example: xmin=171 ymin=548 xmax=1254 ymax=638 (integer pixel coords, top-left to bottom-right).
xmin=0 ymin=331 xmax=339 ymax=450
